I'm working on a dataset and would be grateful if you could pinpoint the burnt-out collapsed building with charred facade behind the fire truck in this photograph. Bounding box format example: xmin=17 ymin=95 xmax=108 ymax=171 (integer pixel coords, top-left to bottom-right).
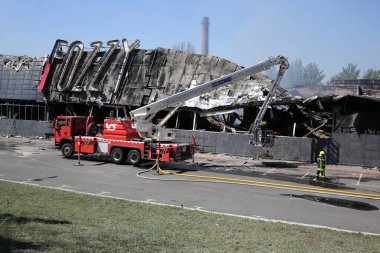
xmin=0 ymin=39 xmax=380 ymax=166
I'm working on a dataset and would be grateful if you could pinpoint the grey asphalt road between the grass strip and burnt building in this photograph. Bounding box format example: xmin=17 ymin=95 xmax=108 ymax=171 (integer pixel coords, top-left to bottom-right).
xmin=0 ymin=138 xmax=380 ymax=234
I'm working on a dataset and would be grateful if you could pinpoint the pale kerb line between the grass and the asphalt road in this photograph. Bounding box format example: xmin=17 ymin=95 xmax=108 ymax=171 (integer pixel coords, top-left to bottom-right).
xmin=0 ymin=178 xmax=380 ymax=236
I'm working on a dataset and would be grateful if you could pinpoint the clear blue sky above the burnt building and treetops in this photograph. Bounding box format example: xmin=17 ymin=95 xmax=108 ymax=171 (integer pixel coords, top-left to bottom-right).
xmin=0 ymin=0 xmax=380 ymax=81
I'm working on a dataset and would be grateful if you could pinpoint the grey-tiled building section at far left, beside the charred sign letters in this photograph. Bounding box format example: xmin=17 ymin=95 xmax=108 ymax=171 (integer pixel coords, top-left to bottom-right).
xmin=0 ymin=55 xmax=51 ymax=136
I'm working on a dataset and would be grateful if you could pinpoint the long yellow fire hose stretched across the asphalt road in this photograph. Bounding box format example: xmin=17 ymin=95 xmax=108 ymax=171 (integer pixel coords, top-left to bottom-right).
xmin=159 ymin=168 xmax=380 ymax=199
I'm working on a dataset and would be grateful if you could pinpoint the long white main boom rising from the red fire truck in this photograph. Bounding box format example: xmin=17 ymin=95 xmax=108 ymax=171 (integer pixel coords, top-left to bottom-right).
xmin=130 ymin=55 xmax=288 ymax=140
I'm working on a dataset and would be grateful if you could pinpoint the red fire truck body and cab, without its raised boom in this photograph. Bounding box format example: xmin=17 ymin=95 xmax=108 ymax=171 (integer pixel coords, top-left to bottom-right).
xmin=54 ymin=116 xmax=193 ymax=165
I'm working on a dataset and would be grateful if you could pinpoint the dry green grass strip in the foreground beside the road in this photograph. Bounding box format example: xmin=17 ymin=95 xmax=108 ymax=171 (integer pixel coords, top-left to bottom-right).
xmin=0 ymin=182 xmax=380 ymax=252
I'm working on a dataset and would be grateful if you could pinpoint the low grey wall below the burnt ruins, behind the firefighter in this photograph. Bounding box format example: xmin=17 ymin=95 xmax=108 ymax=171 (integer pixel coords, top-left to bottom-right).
xmin=175 ymin=130 xmax=380 ymax=167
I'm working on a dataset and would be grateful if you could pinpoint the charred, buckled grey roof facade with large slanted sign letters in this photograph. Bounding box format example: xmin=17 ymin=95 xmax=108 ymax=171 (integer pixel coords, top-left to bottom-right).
xmin=42 ymin=40 xmax=296 ymax=110
